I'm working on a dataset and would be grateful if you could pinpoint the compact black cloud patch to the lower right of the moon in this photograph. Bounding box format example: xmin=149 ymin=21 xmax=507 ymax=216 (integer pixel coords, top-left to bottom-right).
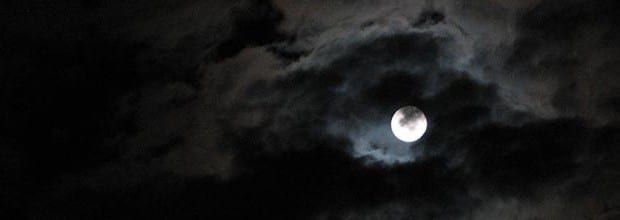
xmin=461 ymin=120 xmax=590 ymax=192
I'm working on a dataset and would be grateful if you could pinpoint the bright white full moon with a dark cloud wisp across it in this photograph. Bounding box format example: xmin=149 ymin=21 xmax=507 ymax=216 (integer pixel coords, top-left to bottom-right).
xmin=391 ymin=106 xmax=428 ymax=142
